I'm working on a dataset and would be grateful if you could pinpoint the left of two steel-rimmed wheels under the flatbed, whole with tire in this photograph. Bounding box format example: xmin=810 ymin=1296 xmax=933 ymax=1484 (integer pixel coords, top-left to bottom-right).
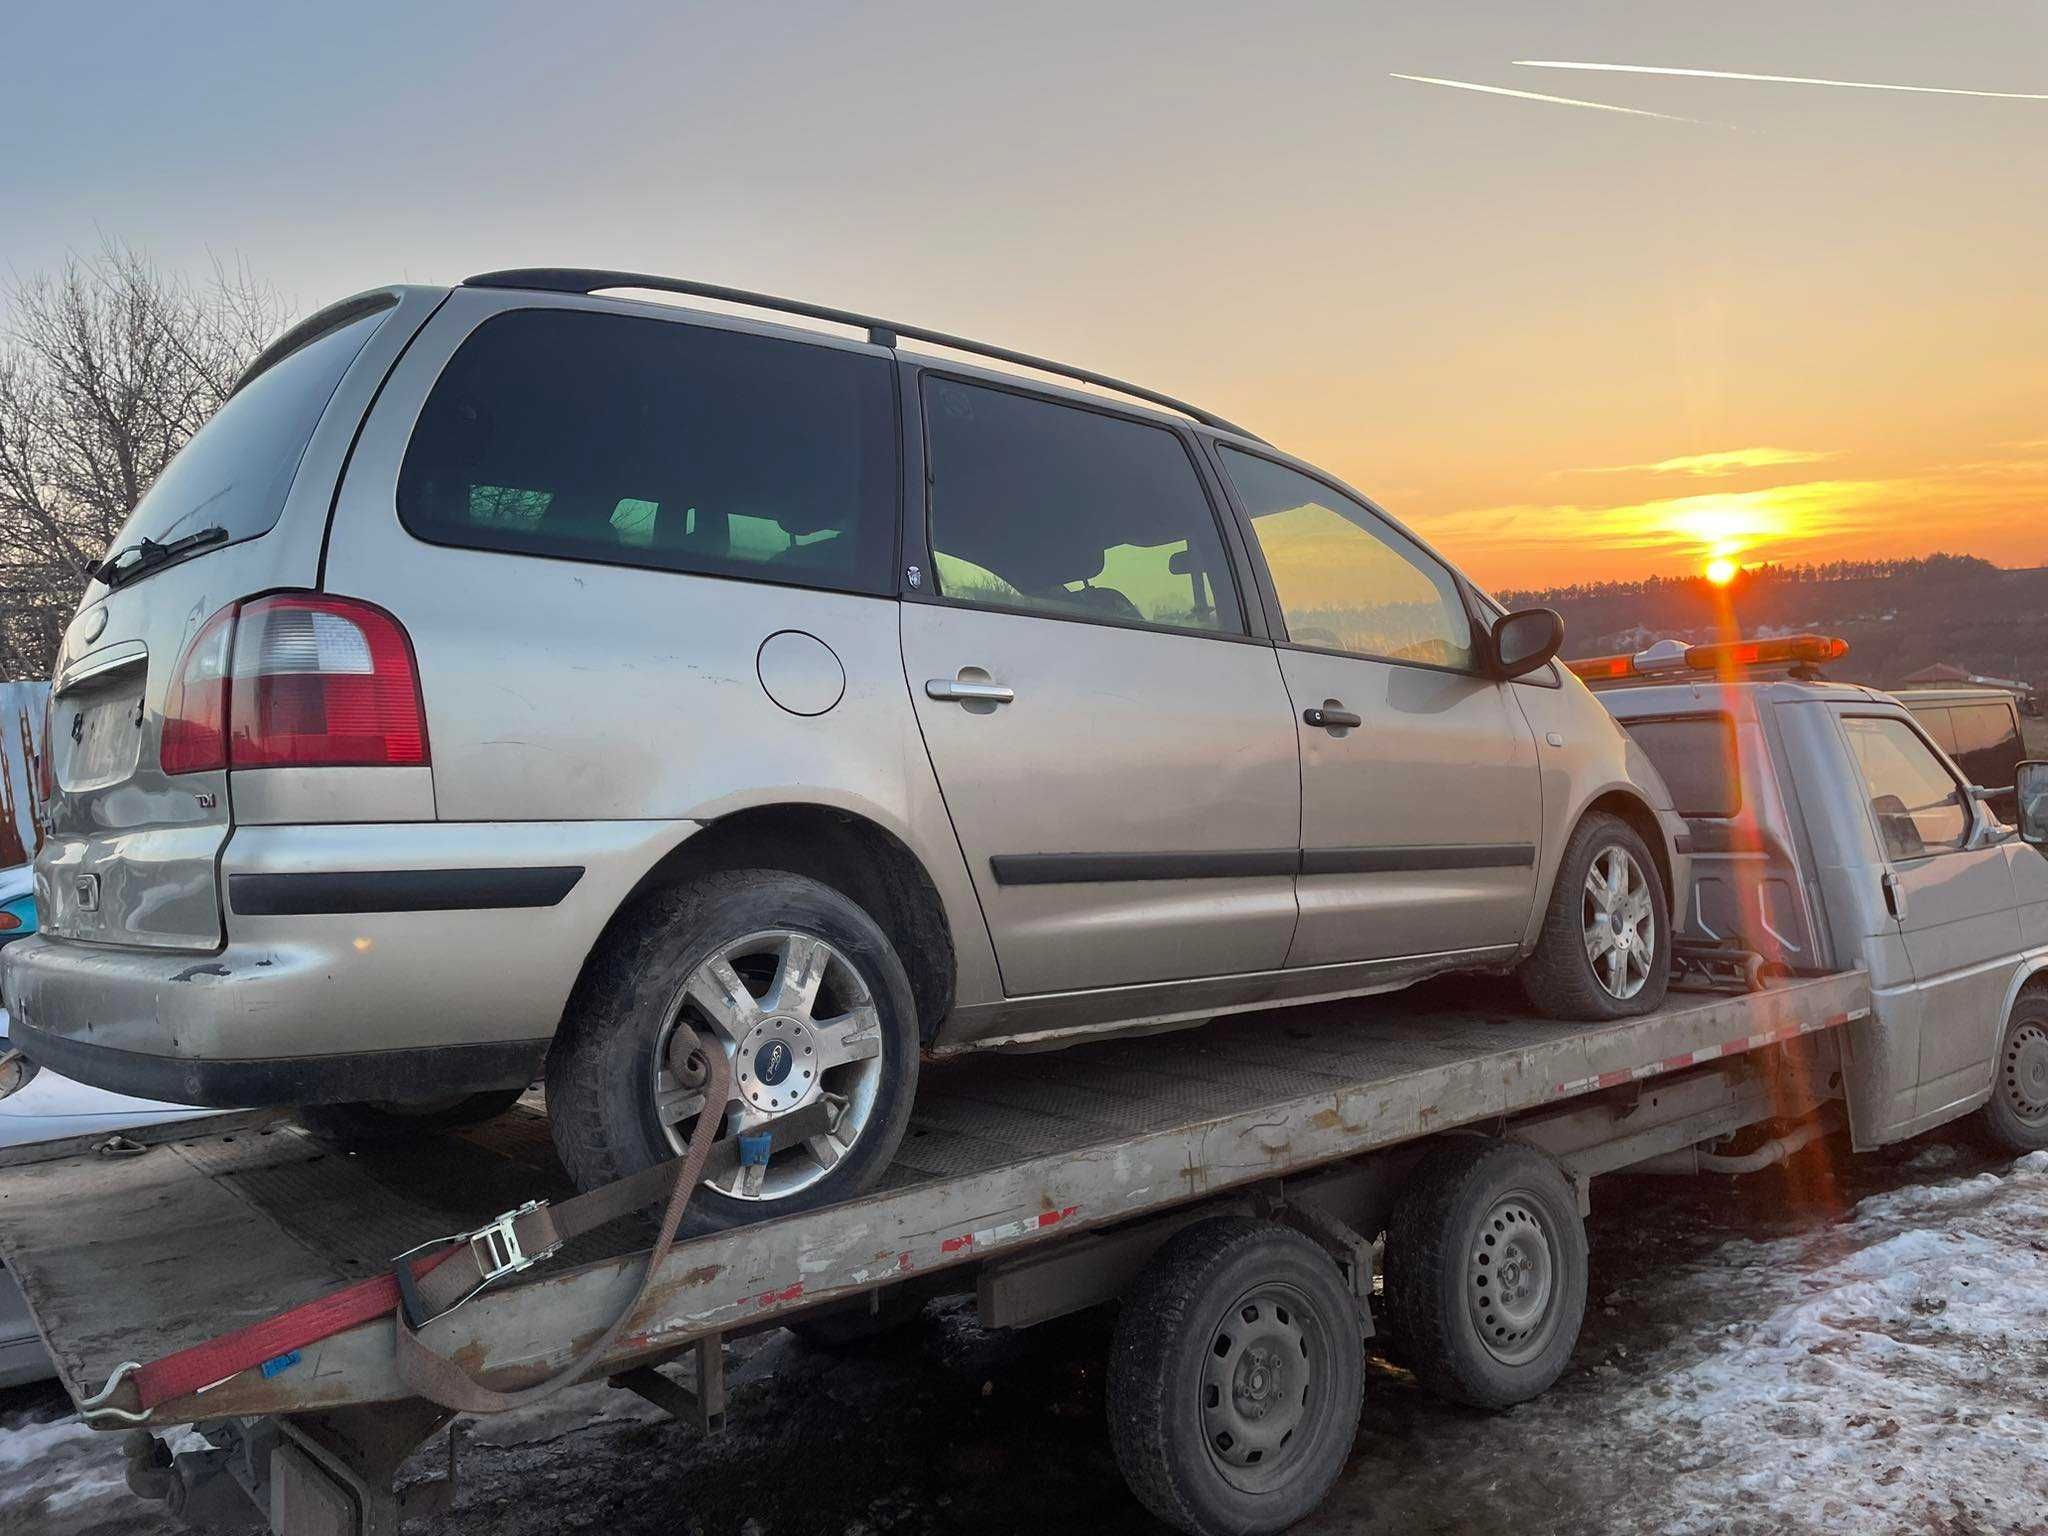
xmin=1108 ymin=1217 xmax=1364 ymax=1536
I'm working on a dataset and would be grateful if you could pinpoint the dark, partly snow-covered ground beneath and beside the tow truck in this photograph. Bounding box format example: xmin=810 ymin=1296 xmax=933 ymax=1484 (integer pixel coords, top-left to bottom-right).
xmin=0 ymin=1141 xmax=2048 ymax=1536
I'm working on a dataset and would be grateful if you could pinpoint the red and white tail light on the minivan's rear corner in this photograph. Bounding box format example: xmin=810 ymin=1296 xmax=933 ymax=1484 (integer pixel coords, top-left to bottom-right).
xmin=162 ymin=592 xmax=428 ymax=774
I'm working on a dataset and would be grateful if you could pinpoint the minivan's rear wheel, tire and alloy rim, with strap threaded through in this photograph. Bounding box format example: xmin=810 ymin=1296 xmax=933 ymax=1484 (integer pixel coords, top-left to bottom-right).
xmin=547 ymin=870 xmax=918 ymax=1237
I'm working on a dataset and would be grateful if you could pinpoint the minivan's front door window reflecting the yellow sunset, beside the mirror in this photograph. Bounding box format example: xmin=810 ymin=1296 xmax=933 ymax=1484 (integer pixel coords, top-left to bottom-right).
xmin=1223 ymin=446 xmax=1475 ymax=670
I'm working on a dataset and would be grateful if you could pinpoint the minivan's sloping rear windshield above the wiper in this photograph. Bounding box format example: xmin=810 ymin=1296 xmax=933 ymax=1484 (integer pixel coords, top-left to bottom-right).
xmin=106 ymin=299 xmax=395 ymax=582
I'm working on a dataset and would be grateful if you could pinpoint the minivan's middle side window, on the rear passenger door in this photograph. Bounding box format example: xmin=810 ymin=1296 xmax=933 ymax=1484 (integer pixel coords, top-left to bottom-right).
xmin=924 ymin=377 xmax=1245 ymax=635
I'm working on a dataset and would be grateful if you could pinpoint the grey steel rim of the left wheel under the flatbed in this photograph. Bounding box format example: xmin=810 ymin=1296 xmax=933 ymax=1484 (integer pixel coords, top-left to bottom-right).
xmin=1200 ymin=1284 xmax=1331 ymax=1493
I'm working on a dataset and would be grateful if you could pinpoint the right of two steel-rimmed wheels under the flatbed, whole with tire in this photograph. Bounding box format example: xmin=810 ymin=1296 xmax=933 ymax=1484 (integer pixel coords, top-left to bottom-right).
xmin=1384 ymin=1137 xmax=1587 ymax=1409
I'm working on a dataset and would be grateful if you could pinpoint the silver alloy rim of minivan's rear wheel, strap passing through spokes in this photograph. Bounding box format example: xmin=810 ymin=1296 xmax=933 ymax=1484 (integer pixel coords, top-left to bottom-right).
xmin=653 ymin=928 xmax=883 ymax=1200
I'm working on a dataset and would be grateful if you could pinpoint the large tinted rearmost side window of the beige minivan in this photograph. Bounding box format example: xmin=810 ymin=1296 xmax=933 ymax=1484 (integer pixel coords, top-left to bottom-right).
xmin=397 ymin=309 xmax=897 ymax=592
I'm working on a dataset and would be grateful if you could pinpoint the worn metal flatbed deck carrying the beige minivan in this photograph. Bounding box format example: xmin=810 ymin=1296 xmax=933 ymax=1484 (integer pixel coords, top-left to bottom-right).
xmin=0 ymin=973 xmax=1870 ymax=1425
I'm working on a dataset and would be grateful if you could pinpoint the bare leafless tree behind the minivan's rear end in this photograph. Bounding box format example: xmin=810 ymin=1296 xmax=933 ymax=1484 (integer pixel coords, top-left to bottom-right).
xmin=0 ymin=242 xmax=287 ymax=678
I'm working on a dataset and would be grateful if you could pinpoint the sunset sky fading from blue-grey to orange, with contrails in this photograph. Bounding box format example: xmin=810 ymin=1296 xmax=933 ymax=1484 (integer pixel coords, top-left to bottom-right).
xmin=0 ymin=0 xmax=2048 ymax=588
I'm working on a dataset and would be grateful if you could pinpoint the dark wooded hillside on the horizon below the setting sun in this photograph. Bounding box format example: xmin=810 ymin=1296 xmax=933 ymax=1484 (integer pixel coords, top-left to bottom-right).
xmin=1499 ymin=555 xmax=2048 ymax=690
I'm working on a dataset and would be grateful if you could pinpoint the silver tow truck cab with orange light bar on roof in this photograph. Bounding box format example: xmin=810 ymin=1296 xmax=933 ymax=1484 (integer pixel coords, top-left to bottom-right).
xmin=1569 ymin=635 xmax=2048 ymax=1147
